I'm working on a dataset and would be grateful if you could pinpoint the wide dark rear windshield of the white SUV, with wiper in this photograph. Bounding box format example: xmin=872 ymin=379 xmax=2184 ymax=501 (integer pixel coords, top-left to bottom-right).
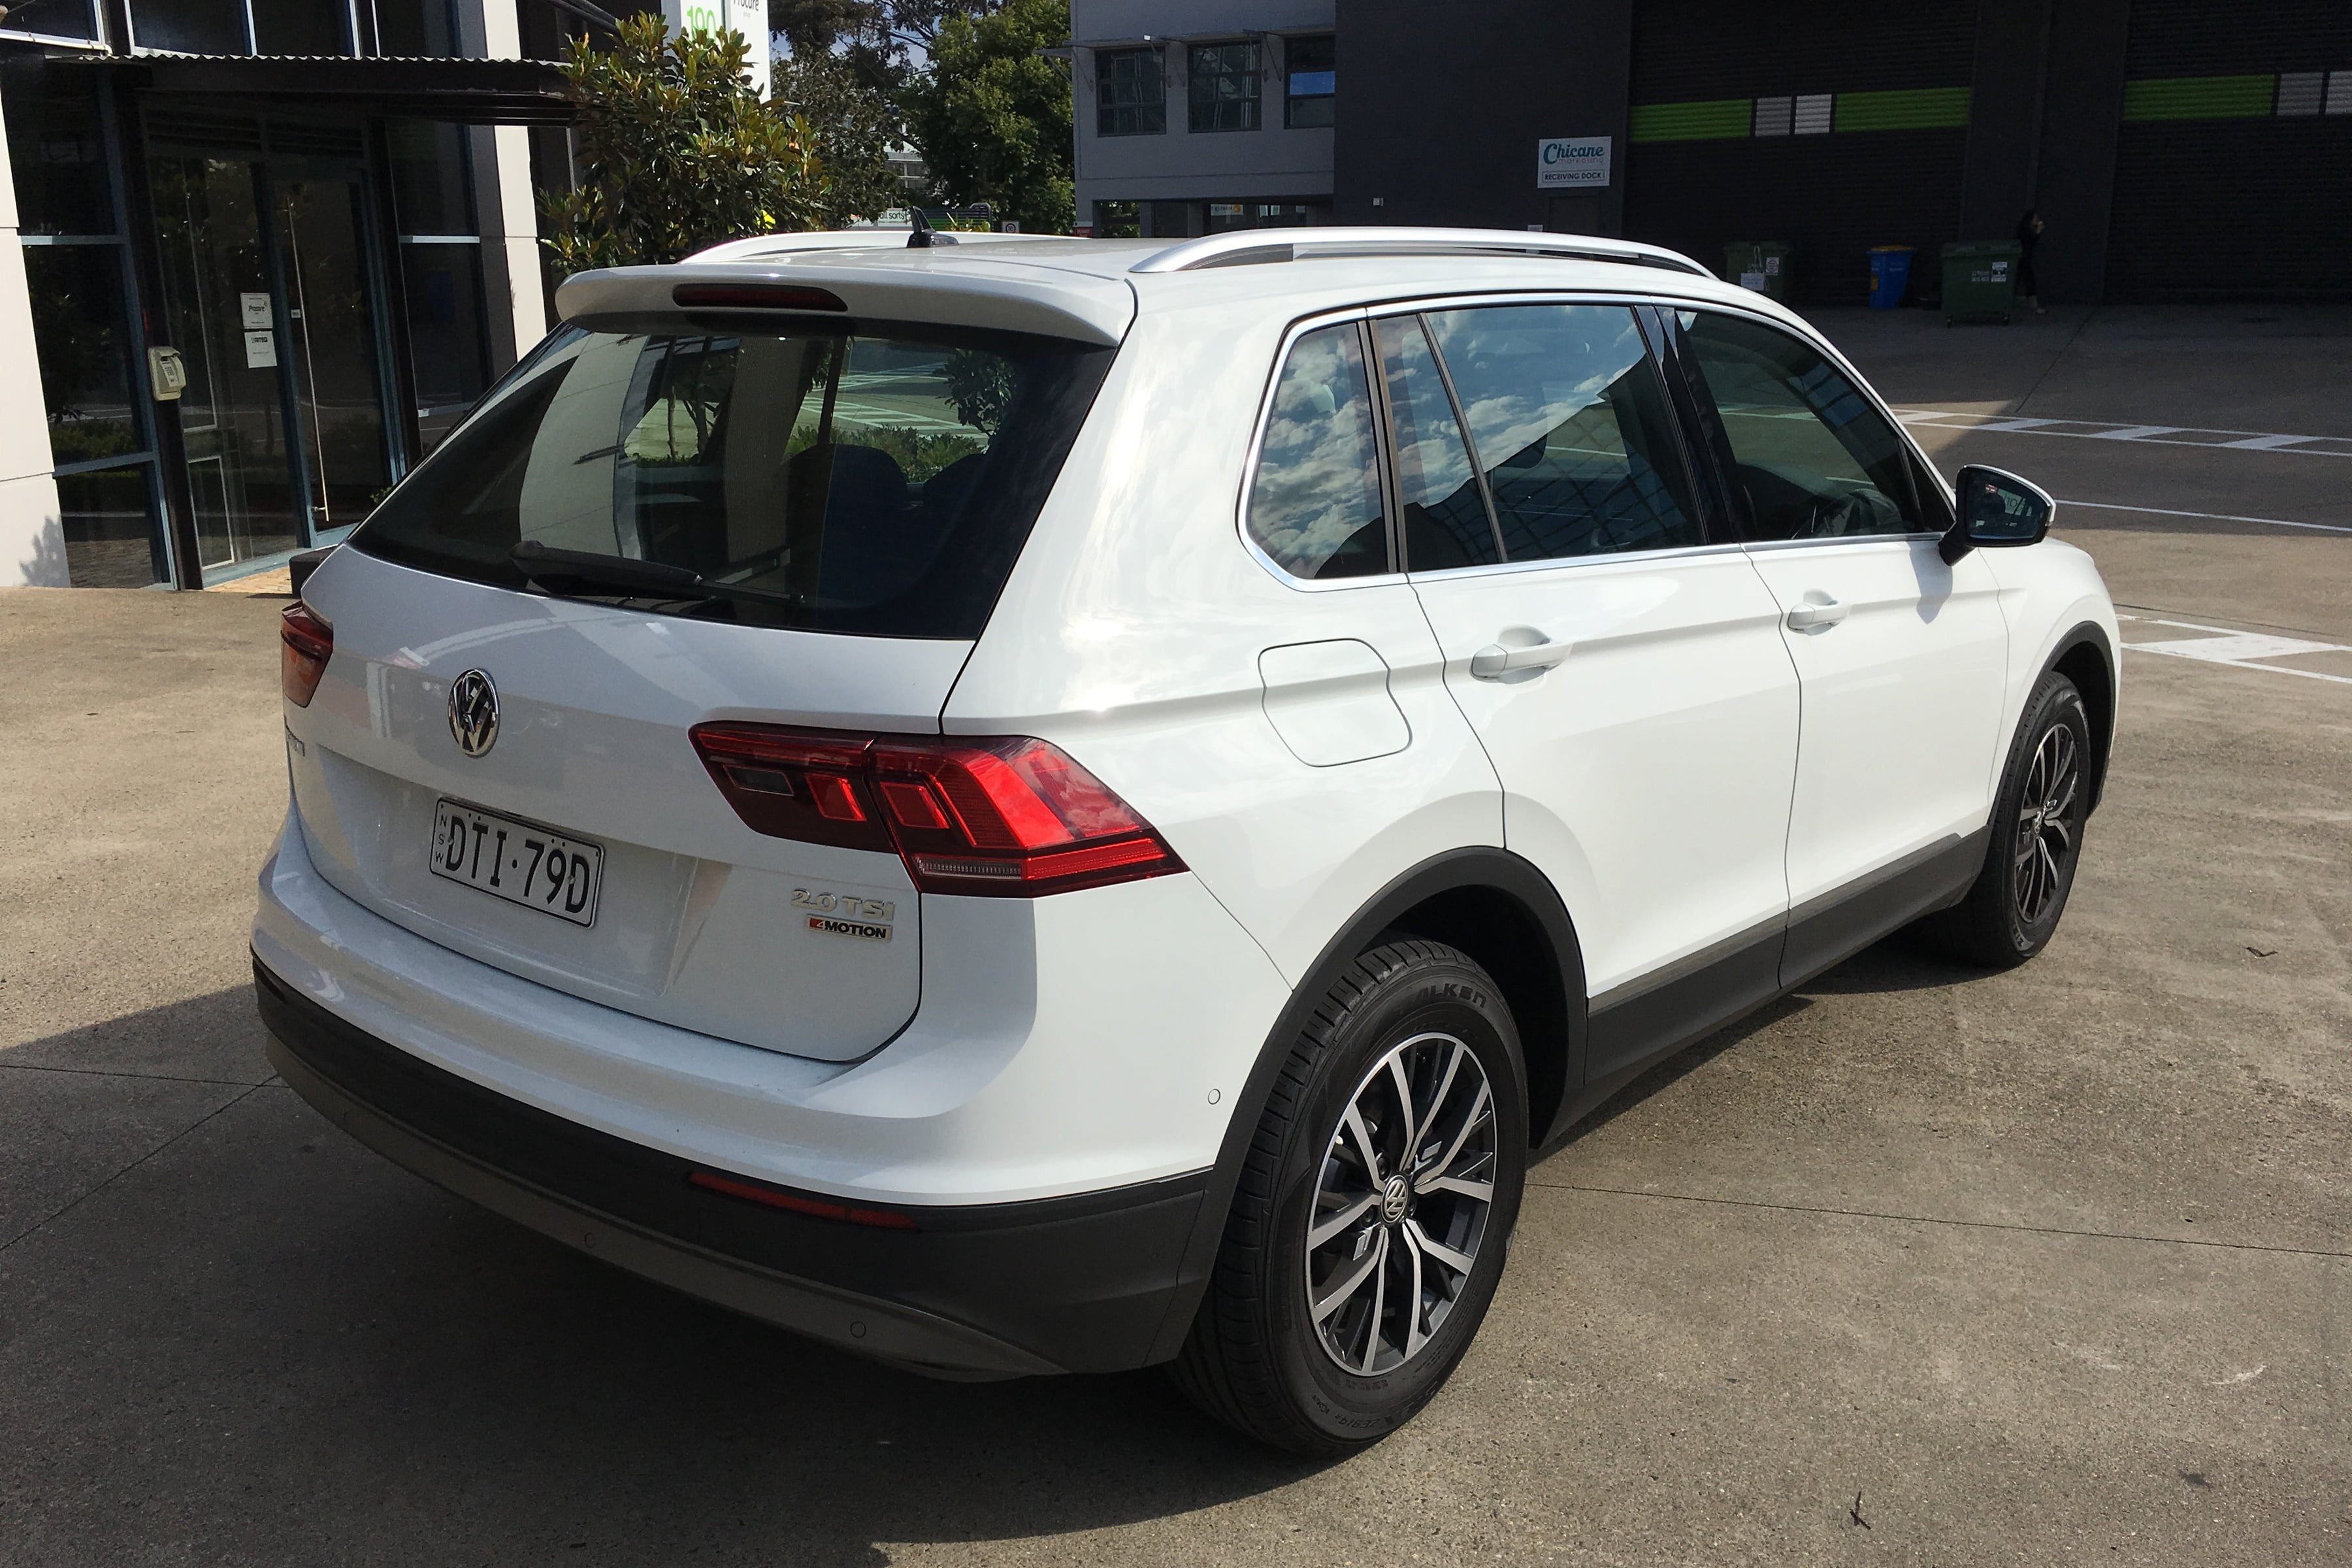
xmin=350 ymin=318 xmax=1113 ymax=637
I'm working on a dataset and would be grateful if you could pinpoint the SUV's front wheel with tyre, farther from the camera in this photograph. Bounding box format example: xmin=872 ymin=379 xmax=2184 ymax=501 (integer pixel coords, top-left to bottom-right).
xmin=1914 ymin=670 xmax=2091 ymax=968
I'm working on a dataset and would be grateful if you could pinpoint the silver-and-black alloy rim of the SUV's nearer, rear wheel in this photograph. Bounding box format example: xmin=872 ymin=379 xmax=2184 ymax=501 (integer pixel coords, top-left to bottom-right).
xmin=1305 ymin=1034 xmax=1496 ymax=1378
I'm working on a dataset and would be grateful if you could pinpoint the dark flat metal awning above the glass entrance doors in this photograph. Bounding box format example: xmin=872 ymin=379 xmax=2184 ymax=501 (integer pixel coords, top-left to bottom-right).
xmin=52 ymin=54 xmax=576 ymax=125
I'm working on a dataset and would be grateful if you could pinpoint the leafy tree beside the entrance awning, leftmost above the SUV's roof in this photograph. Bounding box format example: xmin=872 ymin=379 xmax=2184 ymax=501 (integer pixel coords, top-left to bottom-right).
xmin=541 ymin=16 xmax=823 ymax=272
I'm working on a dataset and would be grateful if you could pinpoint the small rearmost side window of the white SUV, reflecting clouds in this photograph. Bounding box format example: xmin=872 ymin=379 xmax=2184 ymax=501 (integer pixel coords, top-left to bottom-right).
xmin=1249 ymin=322 xmax=1388 ymax=578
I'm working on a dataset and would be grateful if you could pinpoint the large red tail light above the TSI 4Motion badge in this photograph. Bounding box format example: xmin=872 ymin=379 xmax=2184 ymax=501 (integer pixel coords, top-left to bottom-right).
xmin=694 ymin=724 xmax=1183 ymax=898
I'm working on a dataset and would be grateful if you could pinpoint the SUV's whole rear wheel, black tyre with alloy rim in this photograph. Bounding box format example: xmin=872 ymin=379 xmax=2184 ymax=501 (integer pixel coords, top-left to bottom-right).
xmin=1169 ymin=938 xmax=1526 ymax=1458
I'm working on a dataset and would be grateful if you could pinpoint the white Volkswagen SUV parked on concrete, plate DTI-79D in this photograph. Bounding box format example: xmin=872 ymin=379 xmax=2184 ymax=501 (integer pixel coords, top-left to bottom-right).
xmin=254 ymin=231 xmax=2117 ymax=1453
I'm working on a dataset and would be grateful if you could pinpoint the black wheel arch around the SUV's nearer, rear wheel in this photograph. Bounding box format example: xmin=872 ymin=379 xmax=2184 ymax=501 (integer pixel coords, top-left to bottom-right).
xmin=1152 ymin=846 xmax=1585 ymax=1361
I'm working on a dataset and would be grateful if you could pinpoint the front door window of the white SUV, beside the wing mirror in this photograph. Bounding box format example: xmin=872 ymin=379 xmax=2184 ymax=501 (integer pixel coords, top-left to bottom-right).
xmin=1679 ymin=310 xmax=1936 ymax=538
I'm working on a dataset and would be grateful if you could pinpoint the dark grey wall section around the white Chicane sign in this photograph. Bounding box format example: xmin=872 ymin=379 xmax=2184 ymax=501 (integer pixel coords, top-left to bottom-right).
xmin=1331 ymin=0 xmax=1632 ymax=235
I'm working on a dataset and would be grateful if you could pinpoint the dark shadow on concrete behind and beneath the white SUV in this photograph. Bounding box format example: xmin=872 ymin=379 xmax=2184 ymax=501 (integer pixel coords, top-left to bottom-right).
xmin=0 ymin=950 xmax=1964 ymax=1568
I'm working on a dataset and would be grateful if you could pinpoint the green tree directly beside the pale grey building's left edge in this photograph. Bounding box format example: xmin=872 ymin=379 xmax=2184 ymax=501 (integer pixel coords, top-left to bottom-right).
xmin=906 ymin=0 xmax=1075 ymax=235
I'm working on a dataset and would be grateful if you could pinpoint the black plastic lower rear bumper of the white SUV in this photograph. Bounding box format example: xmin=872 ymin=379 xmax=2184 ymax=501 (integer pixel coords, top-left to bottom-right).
xmin=254 ymin=956 xmax=1207 ymax=1378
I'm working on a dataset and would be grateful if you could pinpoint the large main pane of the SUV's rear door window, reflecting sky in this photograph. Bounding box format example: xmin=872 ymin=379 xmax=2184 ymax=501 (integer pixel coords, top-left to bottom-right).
xmin=1428 ymin=306 xmax=1705 ymax=562
